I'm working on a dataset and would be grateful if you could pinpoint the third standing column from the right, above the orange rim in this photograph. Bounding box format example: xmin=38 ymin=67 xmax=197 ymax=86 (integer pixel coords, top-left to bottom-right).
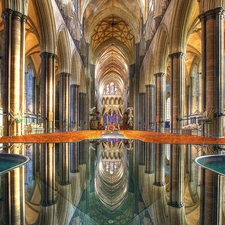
xmin=155 ymin=73 xmax=166 ymax=132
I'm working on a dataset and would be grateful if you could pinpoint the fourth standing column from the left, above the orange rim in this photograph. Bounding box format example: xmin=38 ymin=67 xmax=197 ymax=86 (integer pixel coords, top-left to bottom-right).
xmin=70 ymin=84 xmax=79 ymax=130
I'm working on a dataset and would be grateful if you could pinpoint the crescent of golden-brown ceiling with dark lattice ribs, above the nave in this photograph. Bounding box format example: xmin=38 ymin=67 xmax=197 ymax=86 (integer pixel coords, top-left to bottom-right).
xmin=92 ymin=16 xmax=134 ymax=50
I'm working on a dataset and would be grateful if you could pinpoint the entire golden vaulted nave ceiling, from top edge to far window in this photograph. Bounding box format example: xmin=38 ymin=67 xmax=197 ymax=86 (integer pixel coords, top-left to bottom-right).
xmin=84 ymin=0 xmax=142 ymax=97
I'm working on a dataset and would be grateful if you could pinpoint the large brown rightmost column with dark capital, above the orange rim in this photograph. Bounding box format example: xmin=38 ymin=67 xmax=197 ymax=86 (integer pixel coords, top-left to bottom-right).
xmin=200 ymin=8 xmax=225 ymax=137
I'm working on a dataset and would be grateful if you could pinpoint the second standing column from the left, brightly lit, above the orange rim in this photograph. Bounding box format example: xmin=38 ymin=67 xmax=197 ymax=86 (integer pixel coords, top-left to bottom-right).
xmin=40 ymin=52 xmax=56 ymax=133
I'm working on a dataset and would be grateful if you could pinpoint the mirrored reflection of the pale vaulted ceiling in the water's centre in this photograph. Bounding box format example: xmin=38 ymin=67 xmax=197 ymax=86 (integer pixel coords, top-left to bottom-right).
xmin=95 ymin=141 xmax=128 ymax=210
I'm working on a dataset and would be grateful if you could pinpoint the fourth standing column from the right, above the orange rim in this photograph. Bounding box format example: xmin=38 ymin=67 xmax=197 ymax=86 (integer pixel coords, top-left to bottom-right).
xmin=145 ymin=84 xmax=155 ymax=131
